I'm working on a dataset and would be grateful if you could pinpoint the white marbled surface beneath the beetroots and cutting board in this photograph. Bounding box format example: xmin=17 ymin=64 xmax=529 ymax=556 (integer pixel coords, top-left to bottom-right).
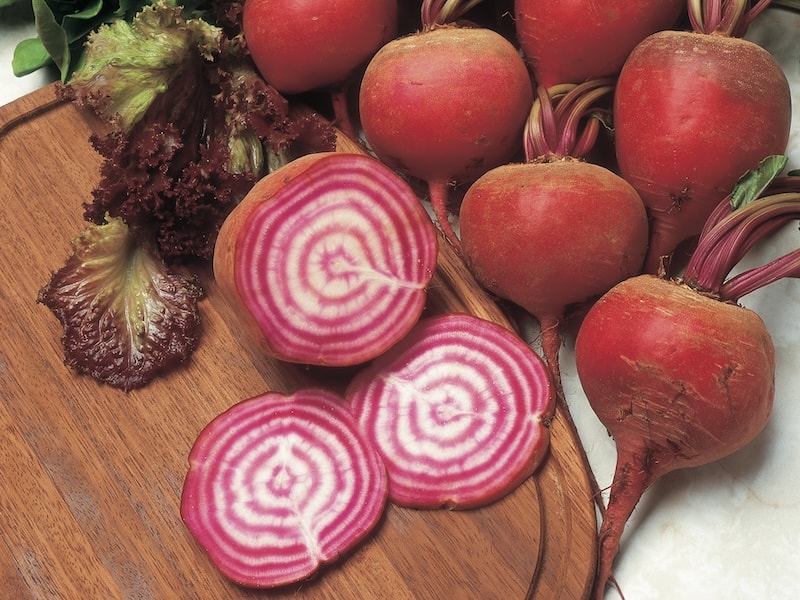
xmin=0 ymin=9 xmax=800 ymax=600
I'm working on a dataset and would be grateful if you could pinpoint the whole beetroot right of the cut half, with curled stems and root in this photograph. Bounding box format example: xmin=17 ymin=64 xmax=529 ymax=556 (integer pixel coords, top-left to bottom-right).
xmin=460 ymin=80 xmax=648 ymax=408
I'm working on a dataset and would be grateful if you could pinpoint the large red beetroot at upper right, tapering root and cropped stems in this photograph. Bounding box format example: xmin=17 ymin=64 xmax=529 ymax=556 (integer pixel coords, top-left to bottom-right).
xmin=614 ymin=0 xmax=791 ymax=273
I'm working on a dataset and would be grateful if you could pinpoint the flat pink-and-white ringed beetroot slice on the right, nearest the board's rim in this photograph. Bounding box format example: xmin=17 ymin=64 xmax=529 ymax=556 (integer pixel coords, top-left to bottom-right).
xmin=345 ymin=313 xmax=554 ymax=508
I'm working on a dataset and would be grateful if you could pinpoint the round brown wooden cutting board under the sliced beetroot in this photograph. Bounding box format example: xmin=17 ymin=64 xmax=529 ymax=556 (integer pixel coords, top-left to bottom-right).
xmin=0 ymin=86 xmax=596 ymax=600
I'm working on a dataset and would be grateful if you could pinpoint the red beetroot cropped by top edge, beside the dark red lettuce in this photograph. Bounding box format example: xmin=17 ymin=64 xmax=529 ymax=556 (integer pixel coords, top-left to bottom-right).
xmin=242 ymin=0 xmax=398 ymax=135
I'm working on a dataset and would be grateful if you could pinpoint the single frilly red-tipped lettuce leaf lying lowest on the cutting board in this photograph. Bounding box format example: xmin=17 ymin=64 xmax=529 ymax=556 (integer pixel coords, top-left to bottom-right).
xmin=38 ymin=218 xmax=202 ymax=391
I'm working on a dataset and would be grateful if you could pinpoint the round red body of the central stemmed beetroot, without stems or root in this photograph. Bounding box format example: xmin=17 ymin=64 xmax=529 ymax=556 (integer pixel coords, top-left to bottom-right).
xmin=461 ymin=159 xmax=647 ymax=318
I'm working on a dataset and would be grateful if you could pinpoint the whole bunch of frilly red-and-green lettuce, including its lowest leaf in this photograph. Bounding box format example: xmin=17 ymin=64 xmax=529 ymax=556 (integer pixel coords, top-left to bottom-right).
xmin=39 ymin=0 xmax=336 ymax=390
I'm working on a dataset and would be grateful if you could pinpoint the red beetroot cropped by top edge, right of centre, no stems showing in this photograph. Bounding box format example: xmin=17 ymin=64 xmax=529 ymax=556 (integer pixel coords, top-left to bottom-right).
xmin=514 ymin=0 xmax=686 ymax=87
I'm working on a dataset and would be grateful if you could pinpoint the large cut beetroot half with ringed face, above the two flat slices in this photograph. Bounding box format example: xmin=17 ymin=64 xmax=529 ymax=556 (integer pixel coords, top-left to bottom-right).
xmin=214 ymin=152 xmax=438 ymax=366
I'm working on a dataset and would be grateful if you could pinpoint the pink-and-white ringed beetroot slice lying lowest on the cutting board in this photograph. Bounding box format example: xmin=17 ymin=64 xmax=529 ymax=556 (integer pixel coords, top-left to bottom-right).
xmin=181 ymin=388 xmax=388 ymax=587
